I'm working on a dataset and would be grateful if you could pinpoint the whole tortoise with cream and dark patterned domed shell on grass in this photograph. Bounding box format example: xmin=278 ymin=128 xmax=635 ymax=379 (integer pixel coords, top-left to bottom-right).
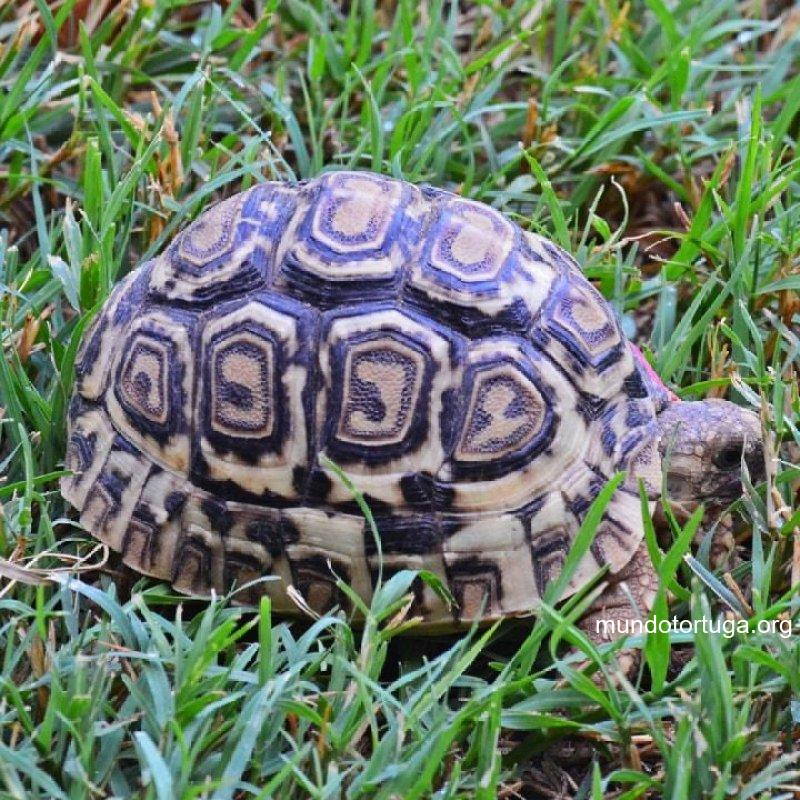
xmin=61 ymin=171 xmax=761 ymax=638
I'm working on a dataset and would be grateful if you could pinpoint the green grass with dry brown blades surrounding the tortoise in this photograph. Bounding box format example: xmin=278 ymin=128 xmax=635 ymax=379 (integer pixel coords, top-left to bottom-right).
xmin=0 ymin=0 xmax=800 ymax=800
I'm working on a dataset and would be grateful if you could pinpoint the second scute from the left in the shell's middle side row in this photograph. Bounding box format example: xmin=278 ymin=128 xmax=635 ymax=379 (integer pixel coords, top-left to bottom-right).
xmin=192 ymin=292 xmax=315 ymax=502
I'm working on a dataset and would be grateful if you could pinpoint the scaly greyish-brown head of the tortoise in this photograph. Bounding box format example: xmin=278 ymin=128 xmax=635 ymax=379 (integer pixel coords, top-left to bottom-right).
xmin=658 ymin=400 xmax=765 ymax=503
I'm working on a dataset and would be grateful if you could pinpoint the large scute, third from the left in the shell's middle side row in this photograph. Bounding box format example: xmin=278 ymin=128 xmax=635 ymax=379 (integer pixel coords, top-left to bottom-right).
xmin=317 ymin=304 xmax=463 ymax=506
